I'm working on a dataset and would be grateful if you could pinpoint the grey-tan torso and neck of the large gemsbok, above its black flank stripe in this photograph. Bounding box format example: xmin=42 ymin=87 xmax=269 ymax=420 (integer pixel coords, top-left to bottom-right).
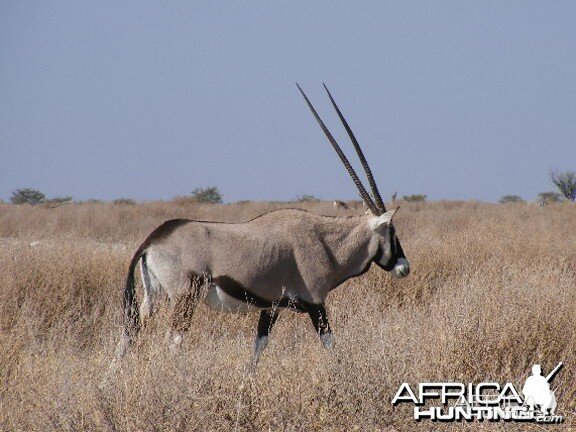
xmin=142 ymin=209 xmax=396 ymax=309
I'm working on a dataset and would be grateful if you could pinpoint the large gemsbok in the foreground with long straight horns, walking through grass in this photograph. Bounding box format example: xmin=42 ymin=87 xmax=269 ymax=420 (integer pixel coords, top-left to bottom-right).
xmin=115 ymin=84 xmax=410 ymax=368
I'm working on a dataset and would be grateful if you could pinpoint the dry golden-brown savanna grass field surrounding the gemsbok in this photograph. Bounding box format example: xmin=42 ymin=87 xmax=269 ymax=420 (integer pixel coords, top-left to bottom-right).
xmin=0 ymin=200 xmax=576 ymax=432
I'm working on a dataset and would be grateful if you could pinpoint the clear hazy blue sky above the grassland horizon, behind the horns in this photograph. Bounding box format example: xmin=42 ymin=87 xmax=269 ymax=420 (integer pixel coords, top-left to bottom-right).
xmin=0 ymin=0 xmax=576 ymax=201
